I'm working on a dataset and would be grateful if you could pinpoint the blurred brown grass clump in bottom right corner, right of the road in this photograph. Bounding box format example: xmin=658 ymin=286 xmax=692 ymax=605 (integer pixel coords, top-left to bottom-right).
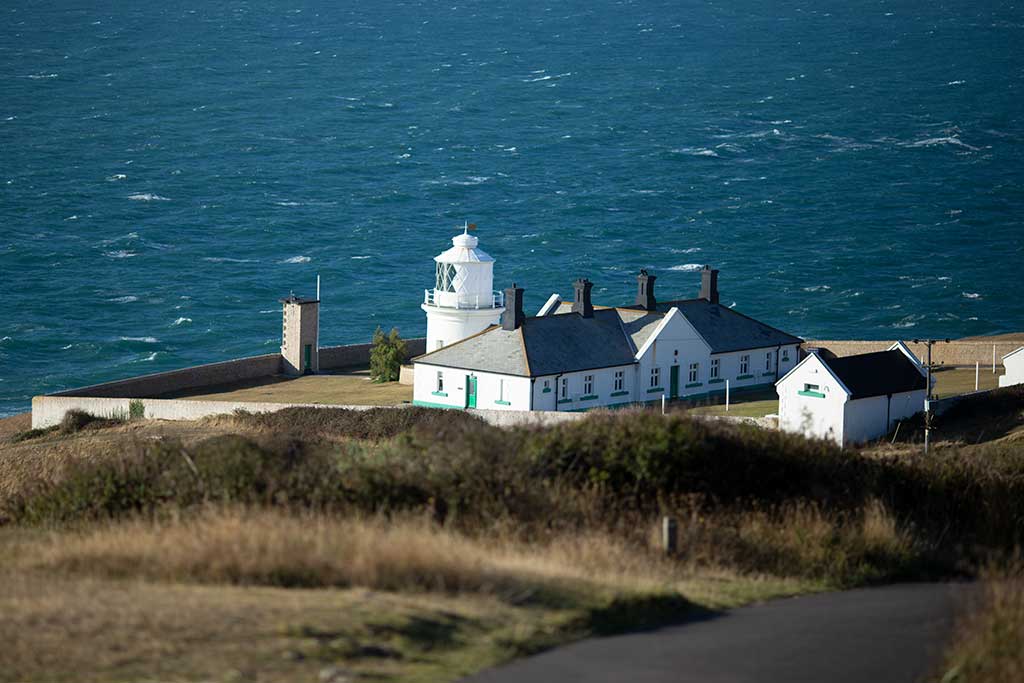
xmin=937 ymin=559 xmax=1024 ymax=683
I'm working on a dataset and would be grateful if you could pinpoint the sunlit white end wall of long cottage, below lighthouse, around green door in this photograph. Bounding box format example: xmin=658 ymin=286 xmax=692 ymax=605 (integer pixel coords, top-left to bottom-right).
xmin=413 ymin=362 xmax=530 ymax=411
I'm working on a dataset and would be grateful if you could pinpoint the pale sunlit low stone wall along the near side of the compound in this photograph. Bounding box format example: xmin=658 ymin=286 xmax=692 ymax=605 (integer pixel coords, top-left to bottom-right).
xmin=32 ymin=396 xmax=586 ymax=429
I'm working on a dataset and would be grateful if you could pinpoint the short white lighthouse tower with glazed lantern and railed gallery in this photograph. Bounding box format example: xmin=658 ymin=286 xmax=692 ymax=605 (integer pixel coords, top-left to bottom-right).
xmin=420 ymin=224 xmax=505 ymax=351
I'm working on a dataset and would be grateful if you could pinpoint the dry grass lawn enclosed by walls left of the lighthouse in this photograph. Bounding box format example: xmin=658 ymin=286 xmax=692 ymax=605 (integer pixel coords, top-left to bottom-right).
xmin=164 ymin=370 xmax=413 ymax=405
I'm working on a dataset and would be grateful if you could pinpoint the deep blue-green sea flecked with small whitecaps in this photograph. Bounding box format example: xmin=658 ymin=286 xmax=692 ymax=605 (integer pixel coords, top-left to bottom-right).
xmin=0 ymin=0 xmax=1024 ymax=416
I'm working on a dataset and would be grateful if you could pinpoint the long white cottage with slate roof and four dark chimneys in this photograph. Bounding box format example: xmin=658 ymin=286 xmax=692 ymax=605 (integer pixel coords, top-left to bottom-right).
xmin=413 ymin=255 xmax=802 ymax=411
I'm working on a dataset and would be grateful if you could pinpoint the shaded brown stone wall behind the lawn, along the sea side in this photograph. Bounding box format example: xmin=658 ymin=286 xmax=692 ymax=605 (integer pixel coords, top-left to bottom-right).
xmin=41 ymin=338 xmax=427 ymax=398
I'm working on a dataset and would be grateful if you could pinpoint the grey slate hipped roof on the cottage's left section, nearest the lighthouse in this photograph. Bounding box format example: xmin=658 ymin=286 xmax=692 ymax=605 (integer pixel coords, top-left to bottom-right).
xmin=414 ymin=308 xmax=636 ymax=377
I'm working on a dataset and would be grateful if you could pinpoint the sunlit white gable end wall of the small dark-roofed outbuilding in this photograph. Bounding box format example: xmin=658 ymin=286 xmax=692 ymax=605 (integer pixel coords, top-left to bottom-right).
xmin=776 ymin=355 xmax=847 ymax=445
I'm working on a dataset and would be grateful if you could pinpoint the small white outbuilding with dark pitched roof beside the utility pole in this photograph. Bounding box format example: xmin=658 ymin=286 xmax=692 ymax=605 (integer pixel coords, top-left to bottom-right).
xmin=775 ymin=342 xmax=928 ymax=446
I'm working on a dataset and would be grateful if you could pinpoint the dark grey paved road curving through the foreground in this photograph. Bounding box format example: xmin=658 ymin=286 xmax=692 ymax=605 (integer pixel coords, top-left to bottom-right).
xmin=465 ymin=584 xmax=973 ymax=683
